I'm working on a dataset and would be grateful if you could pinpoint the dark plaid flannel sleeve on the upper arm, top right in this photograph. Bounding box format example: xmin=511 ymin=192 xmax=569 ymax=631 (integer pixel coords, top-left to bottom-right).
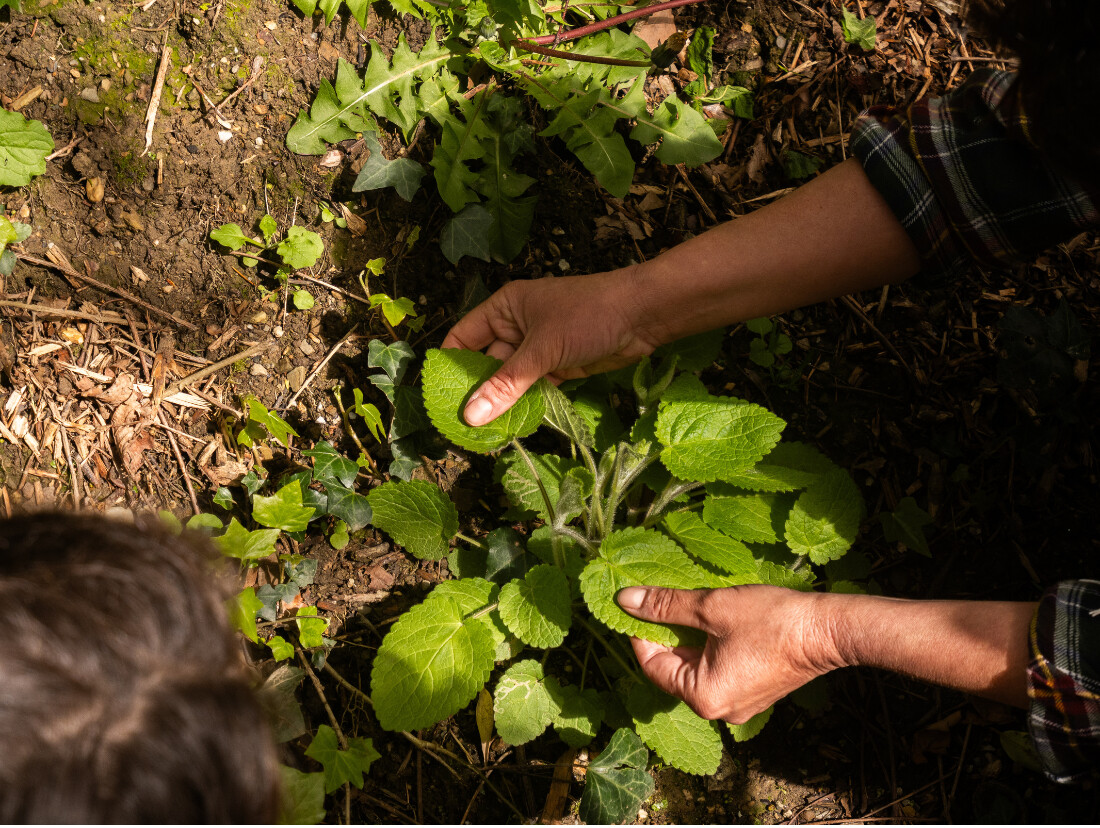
xmin=851 ymin=69 xmax=1100 ymax=278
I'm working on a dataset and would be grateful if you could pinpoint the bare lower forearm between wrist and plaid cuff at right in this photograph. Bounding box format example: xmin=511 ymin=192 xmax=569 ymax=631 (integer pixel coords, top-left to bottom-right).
xmin=820 ymin=595 xmax=1036 ymax=707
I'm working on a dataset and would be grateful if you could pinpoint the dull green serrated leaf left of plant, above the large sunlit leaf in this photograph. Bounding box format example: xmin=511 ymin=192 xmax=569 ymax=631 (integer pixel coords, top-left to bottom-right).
xmin=366 ymin=481 xmax=459 ymax=561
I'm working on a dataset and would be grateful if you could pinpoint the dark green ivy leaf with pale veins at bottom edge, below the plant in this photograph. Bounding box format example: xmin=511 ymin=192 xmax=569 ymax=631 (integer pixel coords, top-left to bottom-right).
xmin=579 ymin=728 xmax=655 ymax=825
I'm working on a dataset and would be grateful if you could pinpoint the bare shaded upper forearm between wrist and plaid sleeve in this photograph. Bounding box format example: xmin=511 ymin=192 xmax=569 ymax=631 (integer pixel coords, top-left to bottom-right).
xmin=630 ymin=161 xmax=920 ymax=342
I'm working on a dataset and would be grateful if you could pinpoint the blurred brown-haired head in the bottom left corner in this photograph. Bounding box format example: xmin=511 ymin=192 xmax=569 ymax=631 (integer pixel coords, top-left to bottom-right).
xmin=0 ymin=512 xmax=277 ymax=823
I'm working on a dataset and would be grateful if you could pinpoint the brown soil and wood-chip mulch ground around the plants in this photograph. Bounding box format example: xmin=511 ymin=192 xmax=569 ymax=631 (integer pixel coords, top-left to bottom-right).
xmin=0 ymin=0 xmax=1100 ymax=824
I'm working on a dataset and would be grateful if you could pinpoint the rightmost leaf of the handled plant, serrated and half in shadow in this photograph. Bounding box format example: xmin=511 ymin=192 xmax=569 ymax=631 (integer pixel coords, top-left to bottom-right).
xmin=785 ymin=468 xmax=864 ymax=564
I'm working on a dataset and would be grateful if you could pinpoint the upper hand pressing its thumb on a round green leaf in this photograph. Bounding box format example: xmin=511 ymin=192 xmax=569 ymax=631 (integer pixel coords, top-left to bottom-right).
xmin=443 ymin=268 xmax=660 ymax=426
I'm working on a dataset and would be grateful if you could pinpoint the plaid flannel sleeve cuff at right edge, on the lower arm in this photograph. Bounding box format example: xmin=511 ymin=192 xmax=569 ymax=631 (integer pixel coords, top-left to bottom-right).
xmin=1027 ymin=581 xmax=1100 ymax=782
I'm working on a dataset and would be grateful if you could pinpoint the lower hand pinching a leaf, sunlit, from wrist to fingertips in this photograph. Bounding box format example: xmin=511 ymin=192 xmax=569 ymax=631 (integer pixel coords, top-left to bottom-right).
xmin=616 ymin=585 xmax=845 ymax=725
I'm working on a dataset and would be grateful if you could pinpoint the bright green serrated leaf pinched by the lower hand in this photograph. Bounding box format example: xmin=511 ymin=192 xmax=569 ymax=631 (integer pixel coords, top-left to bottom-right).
xmin=581 ymin=527 xmax=710 ymax=645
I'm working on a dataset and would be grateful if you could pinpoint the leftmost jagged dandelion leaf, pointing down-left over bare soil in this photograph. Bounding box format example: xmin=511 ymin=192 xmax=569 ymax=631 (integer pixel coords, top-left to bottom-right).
xmin=286 ymin=33 xmax=452 ymax=155
